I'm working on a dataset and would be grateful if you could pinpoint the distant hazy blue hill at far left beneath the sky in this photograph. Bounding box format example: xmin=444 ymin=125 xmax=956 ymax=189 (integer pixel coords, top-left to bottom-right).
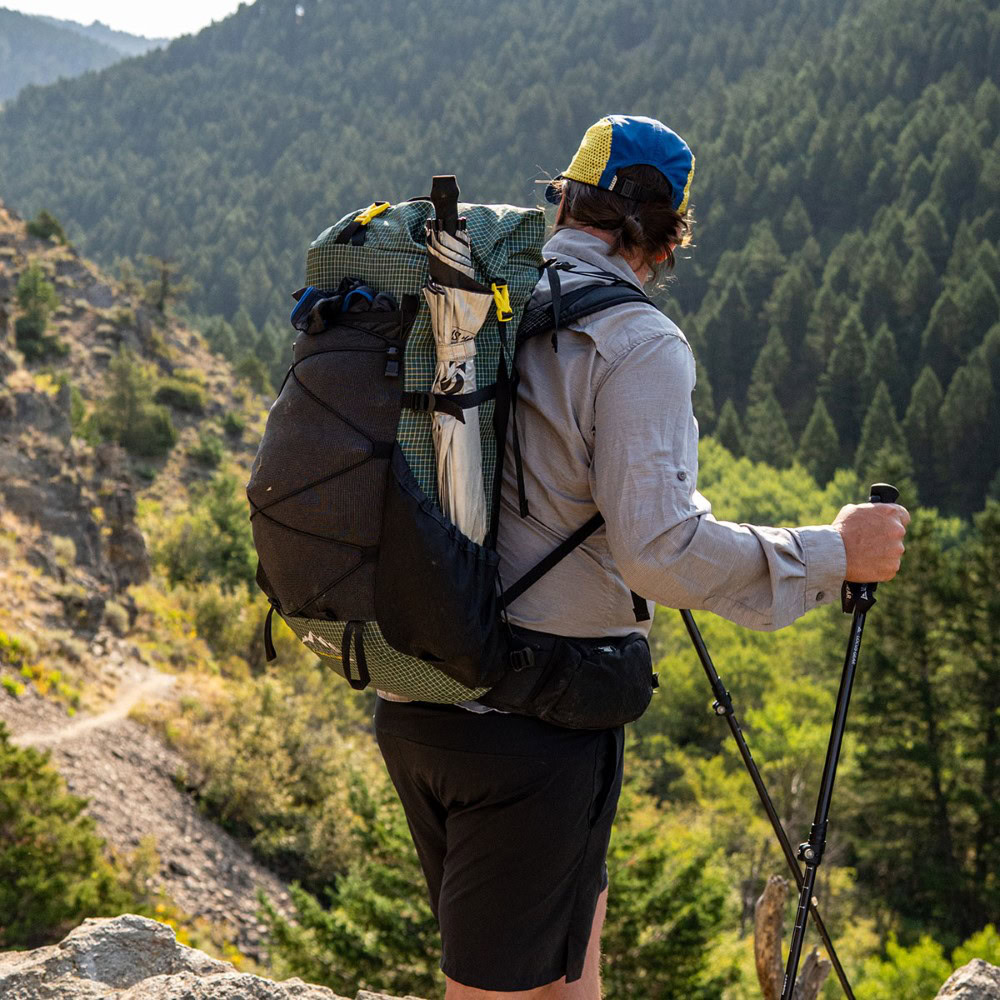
xmin=0 ymin=7 xmax=122 ymax=103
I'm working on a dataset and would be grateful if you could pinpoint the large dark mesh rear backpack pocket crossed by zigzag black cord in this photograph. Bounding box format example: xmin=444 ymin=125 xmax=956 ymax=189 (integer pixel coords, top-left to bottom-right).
xmin=247 ymin=296 xmax=417 ymax=621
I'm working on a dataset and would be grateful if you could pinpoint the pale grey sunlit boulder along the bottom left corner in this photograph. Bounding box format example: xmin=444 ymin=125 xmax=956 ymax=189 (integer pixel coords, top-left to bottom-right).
xmin=0 ymin=914 xmax=426 ymax=1000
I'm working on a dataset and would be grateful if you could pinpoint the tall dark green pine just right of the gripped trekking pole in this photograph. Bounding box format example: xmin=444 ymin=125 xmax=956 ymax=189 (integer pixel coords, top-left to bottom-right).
xmin=851 ymin=511 xmax=965 ymax=934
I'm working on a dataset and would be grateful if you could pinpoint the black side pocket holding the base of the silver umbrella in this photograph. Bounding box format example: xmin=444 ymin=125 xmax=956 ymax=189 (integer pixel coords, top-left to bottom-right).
xmin=375 ymin=447 xmax=507 ymax=688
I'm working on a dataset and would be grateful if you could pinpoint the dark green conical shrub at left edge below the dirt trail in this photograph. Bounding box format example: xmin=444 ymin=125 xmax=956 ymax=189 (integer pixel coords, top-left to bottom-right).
xmin=0 ymin=723 xmax=133 ymax=949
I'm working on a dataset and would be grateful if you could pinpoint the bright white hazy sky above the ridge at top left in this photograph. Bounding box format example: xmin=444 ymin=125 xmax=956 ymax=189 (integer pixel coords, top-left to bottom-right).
xmin=0 ymin=0 xmax=246 ymax=38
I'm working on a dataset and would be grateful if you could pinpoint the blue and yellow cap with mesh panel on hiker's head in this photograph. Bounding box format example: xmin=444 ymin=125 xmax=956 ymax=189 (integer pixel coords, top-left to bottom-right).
xmin=545 ymin=115 xmax=694 ymax=212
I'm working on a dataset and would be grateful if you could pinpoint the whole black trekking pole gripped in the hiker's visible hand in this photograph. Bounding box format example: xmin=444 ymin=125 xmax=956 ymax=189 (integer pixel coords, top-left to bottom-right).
xmin=781 ymin=483 xmax=899 ymax=1000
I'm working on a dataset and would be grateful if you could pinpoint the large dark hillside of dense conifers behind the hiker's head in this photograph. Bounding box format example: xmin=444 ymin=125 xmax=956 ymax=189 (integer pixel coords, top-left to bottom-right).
xmin=0 ymin=0 xmax=1000 ymax=513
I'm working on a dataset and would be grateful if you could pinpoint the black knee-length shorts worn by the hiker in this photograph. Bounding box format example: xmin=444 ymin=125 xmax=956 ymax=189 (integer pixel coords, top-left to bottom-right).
xmin=375 ymin=698 xmax=624 ymax=992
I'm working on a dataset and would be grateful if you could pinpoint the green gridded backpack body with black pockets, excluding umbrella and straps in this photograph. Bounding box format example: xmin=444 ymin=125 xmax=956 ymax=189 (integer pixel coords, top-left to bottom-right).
xmin=247 ymin=189 xmax=545 ymax=703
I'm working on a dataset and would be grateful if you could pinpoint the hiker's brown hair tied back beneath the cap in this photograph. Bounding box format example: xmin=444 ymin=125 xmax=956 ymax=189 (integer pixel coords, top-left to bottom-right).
xmin=554 ymin=163 xmax=694 ymax=278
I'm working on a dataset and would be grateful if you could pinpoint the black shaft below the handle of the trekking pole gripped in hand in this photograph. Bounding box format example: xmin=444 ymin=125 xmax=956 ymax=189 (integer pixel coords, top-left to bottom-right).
xmin=781 ymin=609 xmax=866 ymax=1000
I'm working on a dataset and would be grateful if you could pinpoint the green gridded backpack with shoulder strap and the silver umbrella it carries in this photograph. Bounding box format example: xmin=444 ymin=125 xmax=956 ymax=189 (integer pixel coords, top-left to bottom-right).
xmin=247 ymin=178 xmax=655 ymax=703
